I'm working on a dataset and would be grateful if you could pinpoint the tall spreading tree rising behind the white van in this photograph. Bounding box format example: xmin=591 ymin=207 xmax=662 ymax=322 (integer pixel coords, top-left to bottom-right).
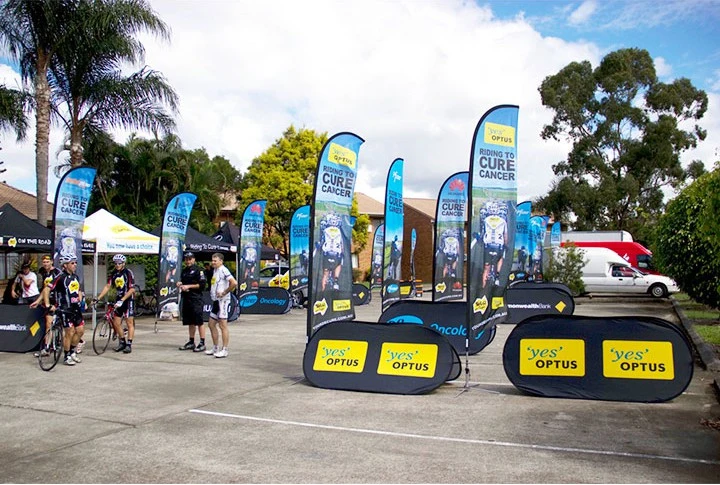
xmin=533 ymin=49 xmax=708 ymax=239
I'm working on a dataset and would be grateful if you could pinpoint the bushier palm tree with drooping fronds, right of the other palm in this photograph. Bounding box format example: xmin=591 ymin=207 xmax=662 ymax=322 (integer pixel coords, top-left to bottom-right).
xmin=50 ymin=0 xmax=178 ymax=167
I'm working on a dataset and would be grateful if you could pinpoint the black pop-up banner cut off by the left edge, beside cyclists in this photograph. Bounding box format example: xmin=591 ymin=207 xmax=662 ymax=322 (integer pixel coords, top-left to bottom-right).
xmin=0 ymin=305 xmax=45 ymax=352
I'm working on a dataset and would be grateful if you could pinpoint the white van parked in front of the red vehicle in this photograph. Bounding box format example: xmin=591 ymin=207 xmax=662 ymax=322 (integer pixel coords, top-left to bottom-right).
xmin=578 ymin=248 xmax=680 ymax=298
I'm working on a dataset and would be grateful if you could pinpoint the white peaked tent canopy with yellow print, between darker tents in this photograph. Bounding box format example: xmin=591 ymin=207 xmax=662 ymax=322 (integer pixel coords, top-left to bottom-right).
xmin=83 ymin=209 xmax=160 ymax=254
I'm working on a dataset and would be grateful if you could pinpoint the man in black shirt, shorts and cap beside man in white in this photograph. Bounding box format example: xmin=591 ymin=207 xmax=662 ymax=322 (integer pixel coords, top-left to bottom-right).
xmin=177 ymin=251 xmax=205 ymax=352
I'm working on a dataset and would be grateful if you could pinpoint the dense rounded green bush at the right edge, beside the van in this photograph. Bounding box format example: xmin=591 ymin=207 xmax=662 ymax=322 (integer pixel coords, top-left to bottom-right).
xmin=653 ymin=165 xmax=720 ymax=308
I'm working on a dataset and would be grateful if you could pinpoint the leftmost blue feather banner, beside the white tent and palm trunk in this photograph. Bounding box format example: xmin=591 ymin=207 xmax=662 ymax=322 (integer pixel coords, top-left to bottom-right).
xmin=53 ymin=167 xmax=96 ymax=289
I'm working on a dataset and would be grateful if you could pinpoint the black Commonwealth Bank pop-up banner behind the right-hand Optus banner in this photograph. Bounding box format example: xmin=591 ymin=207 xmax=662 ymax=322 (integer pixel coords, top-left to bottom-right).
xmin=504 ymin=283 xmax=575 ymax=323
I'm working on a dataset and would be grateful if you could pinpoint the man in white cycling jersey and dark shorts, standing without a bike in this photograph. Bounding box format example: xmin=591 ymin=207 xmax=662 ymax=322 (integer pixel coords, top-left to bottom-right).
xmin=205 ymin=253 xmax=237 ymax=359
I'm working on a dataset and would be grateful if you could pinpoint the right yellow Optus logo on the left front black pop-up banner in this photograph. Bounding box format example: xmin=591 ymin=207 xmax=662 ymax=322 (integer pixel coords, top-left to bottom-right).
xmin=377 ymin=342 xmax=438 ymax=379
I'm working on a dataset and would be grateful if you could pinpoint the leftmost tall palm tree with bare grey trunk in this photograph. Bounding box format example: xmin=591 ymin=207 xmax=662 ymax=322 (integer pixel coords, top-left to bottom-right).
xmin=0 ymin=0 xmax=76 ymax=224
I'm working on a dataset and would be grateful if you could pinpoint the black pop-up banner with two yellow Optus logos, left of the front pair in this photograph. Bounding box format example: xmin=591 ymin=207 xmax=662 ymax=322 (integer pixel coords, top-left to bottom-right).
xmin=303 ymin=322 xmax=460 ymax=394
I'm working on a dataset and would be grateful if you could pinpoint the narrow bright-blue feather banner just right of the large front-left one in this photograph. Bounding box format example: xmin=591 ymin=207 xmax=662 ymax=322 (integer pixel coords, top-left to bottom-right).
xmin=382 ymin=158 xmax=404 ymax=310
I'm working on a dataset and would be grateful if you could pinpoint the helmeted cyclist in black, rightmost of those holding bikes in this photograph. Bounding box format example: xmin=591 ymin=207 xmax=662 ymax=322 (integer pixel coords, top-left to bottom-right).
xmin=96 ymin=254 xmax=135 ymax=354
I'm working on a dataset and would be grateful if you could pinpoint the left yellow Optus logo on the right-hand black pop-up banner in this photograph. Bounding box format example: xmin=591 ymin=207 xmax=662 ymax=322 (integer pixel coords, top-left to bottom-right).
xmin=520 ymin=338 xmax=585 ymax=377
